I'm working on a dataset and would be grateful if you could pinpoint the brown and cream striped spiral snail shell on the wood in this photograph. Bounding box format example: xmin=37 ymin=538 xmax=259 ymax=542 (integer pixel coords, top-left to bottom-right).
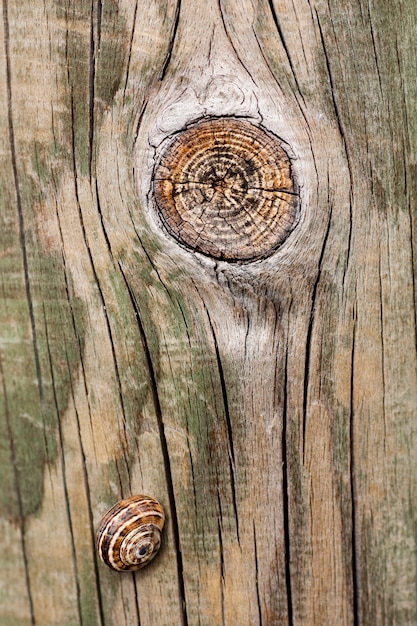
xmin=97 ymin=495 xmax=165 ymax=572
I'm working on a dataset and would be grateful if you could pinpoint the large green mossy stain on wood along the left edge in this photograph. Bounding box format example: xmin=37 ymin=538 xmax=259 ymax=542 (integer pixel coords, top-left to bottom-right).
xmin=0 ymin=165 xmax=84 ymax=518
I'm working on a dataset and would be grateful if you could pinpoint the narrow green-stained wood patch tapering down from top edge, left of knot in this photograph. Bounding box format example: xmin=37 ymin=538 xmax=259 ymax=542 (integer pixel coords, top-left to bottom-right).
xmin=56 ymin=0 xmax=129 ymax=176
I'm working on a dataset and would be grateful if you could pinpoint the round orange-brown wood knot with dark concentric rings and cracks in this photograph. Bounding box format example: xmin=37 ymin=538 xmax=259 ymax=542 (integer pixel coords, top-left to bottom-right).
xmin=154 ymin=118 xmax=299 ymax=262
